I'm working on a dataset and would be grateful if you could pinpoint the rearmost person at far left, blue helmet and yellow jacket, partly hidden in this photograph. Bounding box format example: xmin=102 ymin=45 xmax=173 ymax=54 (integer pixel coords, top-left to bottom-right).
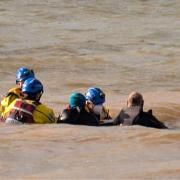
xmin=0 ymin=67 xmax=34 ymax=115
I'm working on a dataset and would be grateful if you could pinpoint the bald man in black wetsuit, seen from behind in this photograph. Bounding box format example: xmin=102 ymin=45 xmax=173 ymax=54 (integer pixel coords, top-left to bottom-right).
xmin=114 ymin=92 xmax=167 ymax=129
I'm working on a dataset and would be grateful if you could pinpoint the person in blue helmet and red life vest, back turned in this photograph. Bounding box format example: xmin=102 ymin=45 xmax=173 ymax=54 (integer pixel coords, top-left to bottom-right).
xmin=1 ymin=78 xmax=55 ymax=124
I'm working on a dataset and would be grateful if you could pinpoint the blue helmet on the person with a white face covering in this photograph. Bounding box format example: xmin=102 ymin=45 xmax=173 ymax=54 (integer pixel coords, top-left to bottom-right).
xmin=85 ymin=87 xmax=105 ymax=105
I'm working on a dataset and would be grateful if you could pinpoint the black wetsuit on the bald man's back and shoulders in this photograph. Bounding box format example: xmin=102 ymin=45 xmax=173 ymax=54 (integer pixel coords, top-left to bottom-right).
xmin=114 ymin=106 xmax=167 ymax=129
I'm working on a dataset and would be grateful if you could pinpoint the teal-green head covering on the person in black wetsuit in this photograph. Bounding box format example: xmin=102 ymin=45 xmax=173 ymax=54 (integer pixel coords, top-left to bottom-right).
xmin=69 ymin=92 xmax=86 ymax=109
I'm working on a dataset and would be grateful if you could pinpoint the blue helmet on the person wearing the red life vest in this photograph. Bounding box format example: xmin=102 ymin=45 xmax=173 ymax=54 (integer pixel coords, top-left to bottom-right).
xmin=22 ymin=78 xmax=43 ymax=94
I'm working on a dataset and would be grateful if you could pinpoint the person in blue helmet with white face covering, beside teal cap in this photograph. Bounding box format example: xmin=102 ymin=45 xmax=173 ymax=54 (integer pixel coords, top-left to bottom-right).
xmin=85 ymin=87 xmax=113 ymax=124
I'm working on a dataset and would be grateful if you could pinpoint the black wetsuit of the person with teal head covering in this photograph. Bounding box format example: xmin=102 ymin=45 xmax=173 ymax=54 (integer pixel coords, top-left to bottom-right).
xmin=58 ymin=108 xmax=99 ymax=126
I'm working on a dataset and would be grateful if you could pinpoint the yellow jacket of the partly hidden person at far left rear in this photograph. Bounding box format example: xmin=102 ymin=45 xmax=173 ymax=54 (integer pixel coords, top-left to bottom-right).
xmin=0 ymin=86 xmax=23 ymax=115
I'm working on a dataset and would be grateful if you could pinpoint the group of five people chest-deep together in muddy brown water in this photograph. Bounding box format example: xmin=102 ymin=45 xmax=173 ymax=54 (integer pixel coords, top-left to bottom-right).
xmin=0 ymin=67 xmax=167 ymax=129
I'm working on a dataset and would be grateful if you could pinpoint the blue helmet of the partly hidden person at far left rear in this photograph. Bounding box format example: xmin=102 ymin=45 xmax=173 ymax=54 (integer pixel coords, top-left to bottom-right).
xmin=16 ymin=67 xmax=34 ymax=83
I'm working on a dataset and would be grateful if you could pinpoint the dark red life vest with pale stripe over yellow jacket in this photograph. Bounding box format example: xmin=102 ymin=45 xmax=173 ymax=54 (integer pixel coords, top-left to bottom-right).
xmin=5 ymin=99 xmax=36 ymax=123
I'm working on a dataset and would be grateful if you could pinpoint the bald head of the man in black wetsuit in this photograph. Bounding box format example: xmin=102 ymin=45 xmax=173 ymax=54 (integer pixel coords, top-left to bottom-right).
xmin=127 ymin=92 xmax=144 ymax=107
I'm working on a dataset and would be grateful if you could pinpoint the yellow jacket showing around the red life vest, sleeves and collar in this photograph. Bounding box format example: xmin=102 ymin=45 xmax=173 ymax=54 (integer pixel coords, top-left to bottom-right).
xmin=1 ymin=99 xmax=55 ymax=124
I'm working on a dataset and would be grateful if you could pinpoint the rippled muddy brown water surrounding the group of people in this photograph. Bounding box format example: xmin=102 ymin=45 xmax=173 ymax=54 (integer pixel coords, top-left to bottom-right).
xmin=0 ymin=0 xmax=180 ymax=179
